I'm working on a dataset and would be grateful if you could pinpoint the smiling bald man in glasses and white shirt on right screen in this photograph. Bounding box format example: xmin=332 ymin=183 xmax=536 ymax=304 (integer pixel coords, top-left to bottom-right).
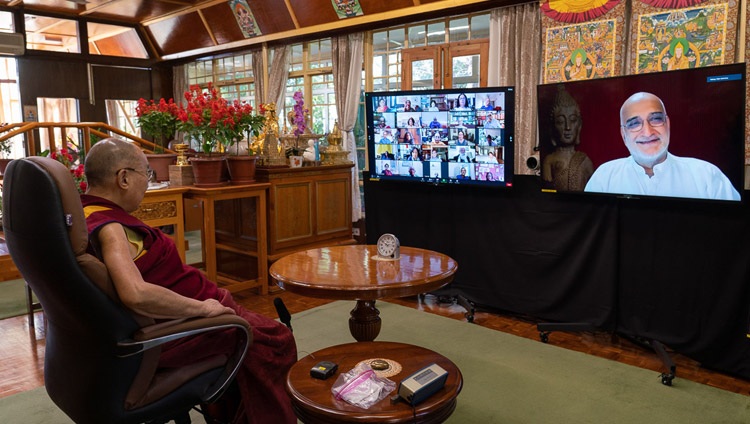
xmin=585 ymin=92 xmax=740 ymax=200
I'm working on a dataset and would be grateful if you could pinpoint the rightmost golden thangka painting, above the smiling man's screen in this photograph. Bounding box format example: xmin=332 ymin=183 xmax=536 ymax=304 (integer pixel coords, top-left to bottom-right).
xmin=631 ymin=2 xmax=737 ymax=74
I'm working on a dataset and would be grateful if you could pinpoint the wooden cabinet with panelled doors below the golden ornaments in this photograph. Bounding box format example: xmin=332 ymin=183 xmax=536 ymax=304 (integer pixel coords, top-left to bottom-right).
xmin=256 ymin=164 xmax=355 ymax=262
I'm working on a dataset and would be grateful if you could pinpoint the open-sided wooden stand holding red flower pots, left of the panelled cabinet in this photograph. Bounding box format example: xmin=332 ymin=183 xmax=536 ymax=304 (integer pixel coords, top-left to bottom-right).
xmin=185 ymin=184 xmax=269 ymax=294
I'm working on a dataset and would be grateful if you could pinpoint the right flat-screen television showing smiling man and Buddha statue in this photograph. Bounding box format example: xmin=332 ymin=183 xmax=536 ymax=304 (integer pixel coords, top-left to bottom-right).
xmin=537 ymin=63 xmax=745 ymax=202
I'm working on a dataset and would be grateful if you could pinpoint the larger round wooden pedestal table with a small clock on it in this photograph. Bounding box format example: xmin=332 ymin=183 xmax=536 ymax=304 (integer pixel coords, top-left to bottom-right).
xmin=269 ymin=245 xmax=458 ymax=342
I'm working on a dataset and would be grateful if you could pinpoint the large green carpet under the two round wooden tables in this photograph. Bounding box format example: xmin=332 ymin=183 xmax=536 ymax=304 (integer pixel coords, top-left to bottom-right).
xmin=0 ymin=301 xmax=750 ymax=424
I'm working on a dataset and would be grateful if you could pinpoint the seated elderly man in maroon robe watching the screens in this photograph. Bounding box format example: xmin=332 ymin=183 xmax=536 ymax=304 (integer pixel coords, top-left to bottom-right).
xmin=81 ymin=138 xmax=297 ymax=423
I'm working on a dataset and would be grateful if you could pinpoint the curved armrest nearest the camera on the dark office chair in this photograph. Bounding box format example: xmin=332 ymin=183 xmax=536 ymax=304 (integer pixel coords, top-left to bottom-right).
xmin=117 ymin=314 xmax=252 ymax=403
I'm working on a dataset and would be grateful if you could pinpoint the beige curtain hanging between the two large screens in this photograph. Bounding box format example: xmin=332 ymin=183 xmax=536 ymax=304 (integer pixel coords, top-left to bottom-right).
xmin=494 ymin=3 xmax=542 ymax=174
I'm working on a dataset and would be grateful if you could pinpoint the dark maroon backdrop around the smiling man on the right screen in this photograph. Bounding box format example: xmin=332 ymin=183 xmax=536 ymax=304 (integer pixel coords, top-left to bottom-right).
xmin=537 ymin=63 xmax=746 ymax=203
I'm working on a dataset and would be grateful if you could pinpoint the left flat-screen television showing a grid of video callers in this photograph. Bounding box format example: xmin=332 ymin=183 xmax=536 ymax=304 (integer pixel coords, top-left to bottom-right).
xmin=365 ymin=87 xmax=515 ymax=187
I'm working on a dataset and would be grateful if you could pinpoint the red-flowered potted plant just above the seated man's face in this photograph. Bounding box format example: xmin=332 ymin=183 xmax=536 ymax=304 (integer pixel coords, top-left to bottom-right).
xmin=135 ymin=98 xmax=179 ymax=181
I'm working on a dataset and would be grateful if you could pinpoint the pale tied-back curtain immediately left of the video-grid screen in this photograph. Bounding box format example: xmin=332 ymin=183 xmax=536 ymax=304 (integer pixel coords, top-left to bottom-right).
xmin=331 ymin=32 xmax=364 ymax=222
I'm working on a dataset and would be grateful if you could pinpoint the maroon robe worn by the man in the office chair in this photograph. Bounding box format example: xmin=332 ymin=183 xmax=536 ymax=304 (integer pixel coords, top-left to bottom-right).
xmin=81 ymin=194 xmax=297 ymax=424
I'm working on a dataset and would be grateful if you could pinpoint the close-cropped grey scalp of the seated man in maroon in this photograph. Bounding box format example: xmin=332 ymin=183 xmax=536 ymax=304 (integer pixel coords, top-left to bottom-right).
xmin=84 ymin=138 xmax=143 ymax=187
